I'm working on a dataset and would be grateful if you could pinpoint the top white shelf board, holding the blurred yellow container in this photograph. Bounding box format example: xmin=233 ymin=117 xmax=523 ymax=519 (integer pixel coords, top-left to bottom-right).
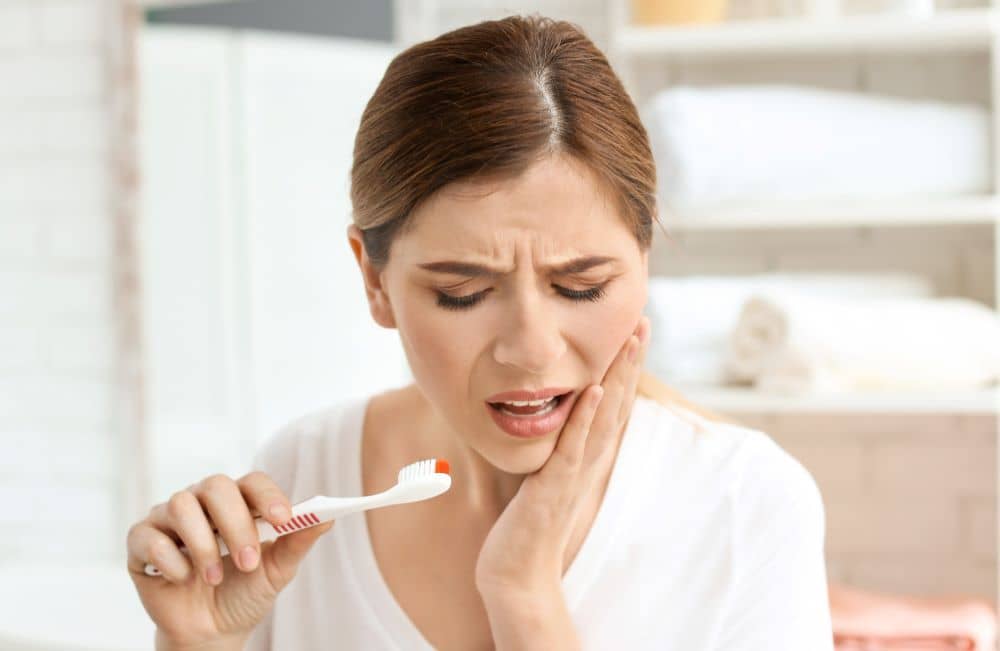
xmin=612 ymin=8 xmax=998 ymax=57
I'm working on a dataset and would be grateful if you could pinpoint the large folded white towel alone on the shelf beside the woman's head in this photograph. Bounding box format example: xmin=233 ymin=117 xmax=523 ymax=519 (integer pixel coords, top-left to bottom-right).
xmin=642 ymin=85 xmax=991 ymax=209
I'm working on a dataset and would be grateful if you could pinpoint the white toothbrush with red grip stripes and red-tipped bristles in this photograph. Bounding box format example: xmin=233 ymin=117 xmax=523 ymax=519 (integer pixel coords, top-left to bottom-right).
xmin=145 ymin=459 xmax=451 ymax=576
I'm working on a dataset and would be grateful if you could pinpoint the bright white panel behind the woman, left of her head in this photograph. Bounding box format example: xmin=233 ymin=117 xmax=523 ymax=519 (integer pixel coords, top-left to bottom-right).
xmin=141 ymin=27 xmax=408 ymax=501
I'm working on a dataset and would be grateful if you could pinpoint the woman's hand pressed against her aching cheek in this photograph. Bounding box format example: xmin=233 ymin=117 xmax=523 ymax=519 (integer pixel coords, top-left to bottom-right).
xmin=476 ymin=317 xmax=649 ymax=601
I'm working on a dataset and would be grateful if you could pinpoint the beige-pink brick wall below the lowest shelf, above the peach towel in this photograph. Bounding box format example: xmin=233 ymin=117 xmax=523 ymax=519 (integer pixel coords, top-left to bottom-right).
xmin=736 ymin=414 xmax=997 ymax=600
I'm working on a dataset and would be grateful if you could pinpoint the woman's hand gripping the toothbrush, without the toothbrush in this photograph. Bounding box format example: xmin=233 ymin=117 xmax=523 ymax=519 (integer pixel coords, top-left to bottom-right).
xmin=127 ymin=472 xmax=333 ymax=649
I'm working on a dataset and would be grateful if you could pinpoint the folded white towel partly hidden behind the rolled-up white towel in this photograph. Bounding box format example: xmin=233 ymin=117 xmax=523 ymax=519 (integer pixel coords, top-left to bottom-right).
xmin=646 ymin=272 xmax=932 ymax=384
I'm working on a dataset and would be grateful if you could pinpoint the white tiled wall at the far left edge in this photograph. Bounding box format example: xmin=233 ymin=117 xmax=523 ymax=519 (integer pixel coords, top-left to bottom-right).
xmin=0 ymin=0 xmax=124 ymax=562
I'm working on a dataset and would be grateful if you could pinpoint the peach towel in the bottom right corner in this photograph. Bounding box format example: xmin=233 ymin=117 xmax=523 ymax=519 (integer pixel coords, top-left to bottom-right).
xmin=830 ymin=584 xmax=997 ymax=651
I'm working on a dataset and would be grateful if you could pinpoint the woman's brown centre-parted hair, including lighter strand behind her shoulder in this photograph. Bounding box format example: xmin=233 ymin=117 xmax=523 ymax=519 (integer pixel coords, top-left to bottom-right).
xmin=351 ymin=14 xmax=725 ymax=430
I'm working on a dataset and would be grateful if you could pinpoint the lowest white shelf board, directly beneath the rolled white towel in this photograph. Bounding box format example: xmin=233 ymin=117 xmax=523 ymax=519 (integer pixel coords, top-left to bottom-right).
xmin=674 ymin=385 xmax=1000 ymax=414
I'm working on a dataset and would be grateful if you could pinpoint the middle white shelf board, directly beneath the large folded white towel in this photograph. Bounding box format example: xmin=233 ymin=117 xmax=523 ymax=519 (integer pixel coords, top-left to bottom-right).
xmin=661 ymin=195 xmax=1000 ymax=231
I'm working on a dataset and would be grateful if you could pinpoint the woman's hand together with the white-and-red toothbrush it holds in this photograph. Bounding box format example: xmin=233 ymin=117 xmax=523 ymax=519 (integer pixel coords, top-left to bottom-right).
xmin=127 ymin=459 xmax=451 ymax=649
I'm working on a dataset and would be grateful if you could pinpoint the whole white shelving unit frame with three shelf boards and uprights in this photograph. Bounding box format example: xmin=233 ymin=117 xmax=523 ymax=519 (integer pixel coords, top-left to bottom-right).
xmin=606 ymin=0 xmax=1000 ymax=414
